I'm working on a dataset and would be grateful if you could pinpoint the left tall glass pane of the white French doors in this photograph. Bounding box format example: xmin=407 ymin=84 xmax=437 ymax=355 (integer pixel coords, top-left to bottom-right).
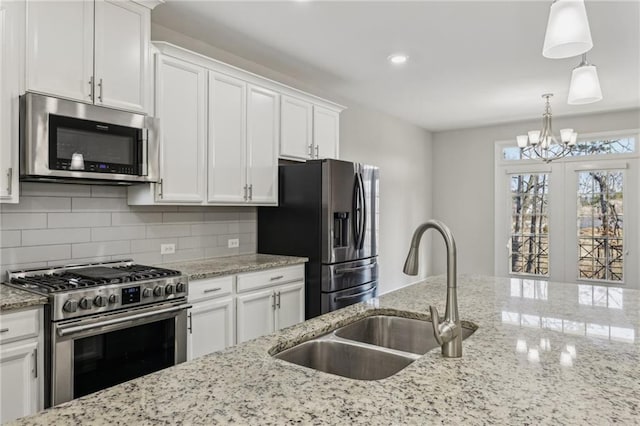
xmin=509 ymin=173 xmax=549 ymax=276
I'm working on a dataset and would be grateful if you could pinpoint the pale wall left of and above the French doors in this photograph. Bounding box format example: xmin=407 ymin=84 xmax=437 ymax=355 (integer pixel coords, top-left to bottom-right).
xmin=431 ymin=110 xmax=640 ymax=275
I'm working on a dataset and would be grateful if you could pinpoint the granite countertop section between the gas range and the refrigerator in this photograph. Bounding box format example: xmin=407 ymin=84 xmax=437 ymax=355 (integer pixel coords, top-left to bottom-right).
xmin=156 ymin=253 xmax=309 ymax=280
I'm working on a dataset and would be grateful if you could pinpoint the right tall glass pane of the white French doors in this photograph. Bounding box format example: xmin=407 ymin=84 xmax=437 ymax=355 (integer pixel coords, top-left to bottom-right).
xmin=577 ymin=170 xmax=624 ymax=281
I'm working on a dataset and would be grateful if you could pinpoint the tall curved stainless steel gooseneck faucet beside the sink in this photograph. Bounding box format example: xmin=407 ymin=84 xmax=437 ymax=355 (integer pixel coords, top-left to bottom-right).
xmin=404 ymin=220 xmax=462 ymax=358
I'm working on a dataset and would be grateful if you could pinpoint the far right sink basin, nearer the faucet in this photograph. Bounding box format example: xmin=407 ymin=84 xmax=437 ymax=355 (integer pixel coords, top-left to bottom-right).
xmin=335 ymin=315 xmax=475 ymax=355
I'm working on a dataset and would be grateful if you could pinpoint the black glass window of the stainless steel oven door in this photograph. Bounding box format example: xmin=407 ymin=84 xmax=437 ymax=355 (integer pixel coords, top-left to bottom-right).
xmin=73 ymin=318 xmax=175 ymax=398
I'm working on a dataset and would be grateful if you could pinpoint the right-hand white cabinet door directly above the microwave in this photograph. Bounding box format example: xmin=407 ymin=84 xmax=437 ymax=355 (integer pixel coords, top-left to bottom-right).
xmin=94 ymin=0 xmax=151 ymax=112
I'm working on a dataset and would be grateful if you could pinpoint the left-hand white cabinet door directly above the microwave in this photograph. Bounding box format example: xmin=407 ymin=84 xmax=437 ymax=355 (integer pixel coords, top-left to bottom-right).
xmin=26 ymin=0 xmax=94 ymax=103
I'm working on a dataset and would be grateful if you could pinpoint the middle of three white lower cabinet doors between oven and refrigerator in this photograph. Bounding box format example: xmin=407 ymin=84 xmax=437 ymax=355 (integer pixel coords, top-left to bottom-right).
xmin=236 ymin=289 xmax=275 ymax=343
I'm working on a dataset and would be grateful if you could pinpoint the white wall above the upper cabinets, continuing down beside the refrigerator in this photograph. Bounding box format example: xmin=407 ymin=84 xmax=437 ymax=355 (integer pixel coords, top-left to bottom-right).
xmin=151 ymin=23 xmax=432 ymax=293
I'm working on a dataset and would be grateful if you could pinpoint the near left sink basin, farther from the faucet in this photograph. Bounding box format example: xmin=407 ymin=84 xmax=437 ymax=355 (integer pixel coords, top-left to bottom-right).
xmin=275 ymin=339 xmax=416 ymax=380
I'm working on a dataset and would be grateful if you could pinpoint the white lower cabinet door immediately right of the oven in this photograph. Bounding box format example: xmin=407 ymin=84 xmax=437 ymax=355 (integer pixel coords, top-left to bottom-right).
xmin=187 ymin=297 xmax=235 ymax=361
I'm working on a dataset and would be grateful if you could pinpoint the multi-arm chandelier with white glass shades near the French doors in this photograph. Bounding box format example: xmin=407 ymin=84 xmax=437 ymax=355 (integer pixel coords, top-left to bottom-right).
xmin=516 ymin=93 xmax=578 ymax=163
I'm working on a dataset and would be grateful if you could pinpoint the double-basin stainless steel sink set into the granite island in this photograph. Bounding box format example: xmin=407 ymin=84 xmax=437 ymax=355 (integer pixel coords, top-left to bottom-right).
xmin=274 ymin=315 xmax=475 ymax=380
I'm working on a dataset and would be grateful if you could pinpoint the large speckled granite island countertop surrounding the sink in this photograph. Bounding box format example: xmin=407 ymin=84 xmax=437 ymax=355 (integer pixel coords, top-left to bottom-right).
xmin=11 ymin=276 xmax=640 ymax=425
